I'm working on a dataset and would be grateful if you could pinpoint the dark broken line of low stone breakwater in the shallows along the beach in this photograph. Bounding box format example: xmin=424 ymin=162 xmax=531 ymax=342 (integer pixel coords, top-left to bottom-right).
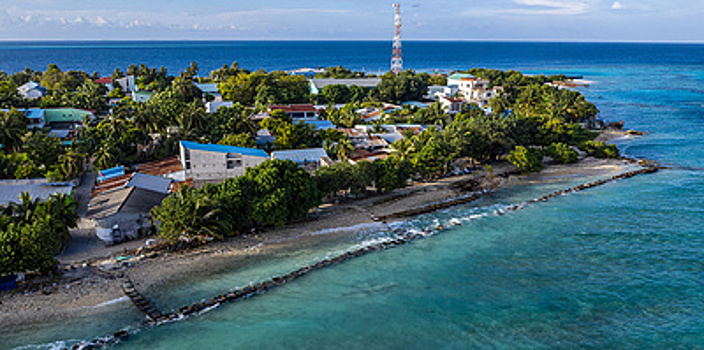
xmin=66 ymin=166 xmax=659 ymax=349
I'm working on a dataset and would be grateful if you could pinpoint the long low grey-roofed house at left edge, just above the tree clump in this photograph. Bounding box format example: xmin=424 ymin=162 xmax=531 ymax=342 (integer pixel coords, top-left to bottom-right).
xmin=0 ymin=179 xmax=73 ymax=207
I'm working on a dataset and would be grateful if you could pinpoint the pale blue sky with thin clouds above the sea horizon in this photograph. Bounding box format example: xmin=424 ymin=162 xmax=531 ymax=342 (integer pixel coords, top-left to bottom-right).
xmin=0 ymin=0 xmax=704 ymax=42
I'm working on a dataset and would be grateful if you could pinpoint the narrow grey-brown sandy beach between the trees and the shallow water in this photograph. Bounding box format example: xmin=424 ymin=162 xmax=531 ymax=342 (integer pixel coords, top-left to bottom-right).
xmin=0 ymin=145 xmax=633 ymax=329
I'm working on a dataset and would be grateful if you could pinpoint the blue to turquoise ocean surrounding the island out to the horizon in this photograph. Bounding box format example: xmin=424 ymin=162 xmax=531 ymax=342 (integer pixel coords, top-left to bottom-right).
xmin=0 ymin=42 xmax=704 ymax=349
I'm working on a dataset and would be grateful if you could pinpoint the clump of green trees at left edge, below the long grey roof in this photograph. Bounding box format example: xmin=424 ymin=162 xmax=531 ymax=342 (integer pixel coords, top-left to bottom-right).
xmin=0 ymin=193 xmax=78 ymax=276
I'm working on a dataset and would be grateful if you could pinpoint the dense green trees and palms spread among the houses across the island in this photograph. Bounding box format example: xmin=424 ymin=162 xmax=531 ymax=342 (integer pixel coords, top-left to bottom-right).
xmin=0 ymin=62 xmax=618 ymax=258
